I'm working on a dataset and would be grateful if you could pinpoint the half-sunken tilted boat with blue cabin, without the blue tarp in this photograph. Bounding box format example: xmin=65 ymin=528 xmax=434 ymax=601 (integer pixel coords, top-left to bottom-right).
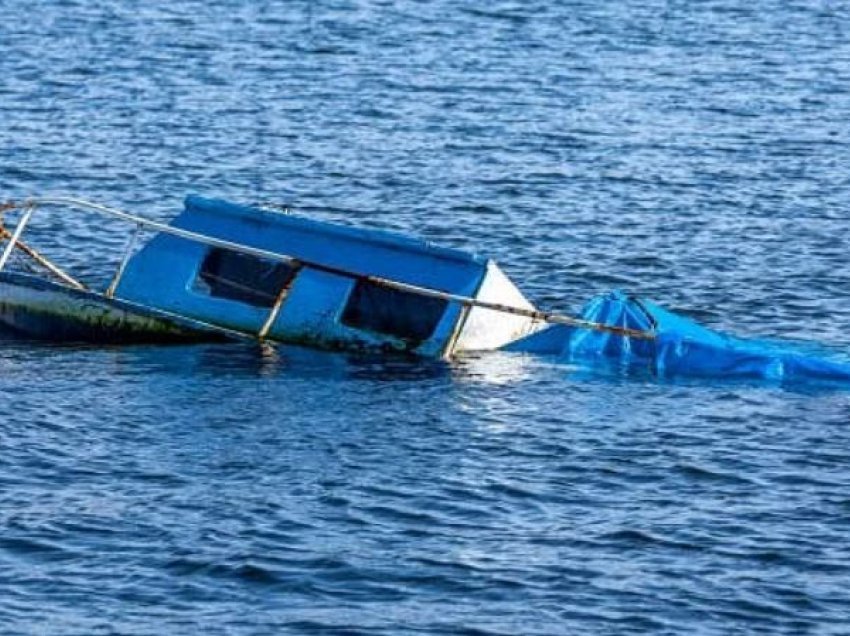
xmin=0 ymin=196 xmax=568 ymax=358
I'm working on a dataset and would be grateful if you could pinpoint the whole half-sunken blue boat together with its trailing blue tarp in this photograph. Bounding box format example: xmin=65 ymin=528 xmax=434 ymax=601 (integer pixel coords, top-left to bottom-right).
xmin=0 ymin=196 xmax=850 ymax=382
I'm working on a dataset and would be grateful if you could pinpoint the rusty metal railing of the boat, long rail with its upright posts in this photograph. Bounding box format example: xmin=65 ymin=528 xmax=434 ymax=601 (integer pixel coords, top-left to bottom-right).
xmin=0 ymin=197 xmax=655 ymax=340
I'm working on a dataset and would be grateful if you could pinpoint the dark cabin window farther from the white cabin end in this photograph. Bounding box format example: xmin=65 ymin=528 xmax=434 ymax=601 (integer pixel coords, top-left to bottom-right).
xmin=196 ymin=248 xmax=298 ymax=307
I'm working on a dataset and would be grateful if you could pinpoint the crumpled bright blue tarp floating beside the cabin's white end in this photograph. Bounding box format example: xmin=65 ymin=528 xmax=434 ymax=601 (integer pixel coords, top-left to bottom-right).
xmin=506 ymin=291 xmax=850 ymax=383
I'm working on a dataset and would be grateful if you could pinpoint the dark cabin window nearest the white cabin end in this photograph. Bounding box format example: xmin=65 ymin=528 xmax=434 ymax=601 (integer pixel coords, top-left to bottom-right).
xmin=342 ymin=280 xmax=448 ymax=340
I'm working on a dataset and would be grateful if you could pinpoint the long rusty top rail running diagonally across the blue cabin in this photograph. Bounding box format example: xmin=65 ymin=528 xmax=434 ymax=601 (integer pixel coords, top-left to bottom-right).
xmin=0 ymin=197 xmax=655 ymax=340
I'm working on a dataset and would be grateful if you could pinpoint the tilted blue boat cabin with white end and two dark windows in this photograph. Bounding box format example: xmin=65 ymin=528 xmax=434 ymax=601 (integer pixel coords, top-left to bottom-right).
xmin=114 ymin=196 xmax=541 ymax=357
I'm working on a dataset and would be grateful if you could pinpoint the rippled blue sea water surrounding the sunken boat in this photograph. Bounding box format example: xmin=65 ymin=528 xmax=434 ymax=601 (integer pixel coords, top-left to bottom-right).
xmin=0 ymin=0 xmax=850 ymax=635
